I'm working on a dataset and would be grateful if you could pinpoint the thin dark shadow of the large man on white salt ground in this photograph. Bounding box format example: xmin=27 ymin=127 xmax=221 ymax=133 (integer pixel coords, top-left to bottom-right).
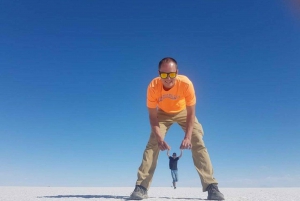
xmin=38 ymin=195 xmax=206 ymax=200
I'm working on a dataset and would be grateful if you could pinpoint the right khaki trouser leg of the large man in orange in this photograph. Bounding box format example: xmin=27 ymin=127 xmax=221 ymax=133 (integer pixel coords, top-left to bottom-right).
xmin=175 ymin=110 xmax=218 ymax=192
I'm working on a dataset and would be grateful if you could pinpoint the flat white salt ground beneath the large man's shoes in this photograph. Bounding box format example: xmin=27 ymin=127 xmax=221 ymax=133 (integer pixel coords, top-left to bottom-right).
xmin=0 ymin=186 xmax=300 ymax=201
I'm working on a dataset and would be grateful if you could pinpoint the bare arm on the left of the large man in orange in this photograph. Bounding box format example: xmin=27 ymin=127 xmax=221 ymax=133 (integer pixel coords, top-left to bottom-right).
xmin=148 ymin=108 xmax=170 ymax=151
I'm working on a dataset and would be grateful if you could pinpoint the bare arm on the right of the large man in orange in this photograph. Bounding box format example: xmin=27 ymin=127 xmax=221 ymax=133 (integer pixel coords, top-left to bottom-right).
xmin=180 ymin=105 xmax=195 ymax=149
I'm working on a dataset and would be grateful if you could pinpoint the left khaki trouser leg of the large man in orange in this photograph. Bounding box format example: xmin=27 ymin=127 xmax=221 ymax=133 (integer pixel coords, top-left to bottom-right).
xmin=136 ymin=111 xmax=172 ymax=189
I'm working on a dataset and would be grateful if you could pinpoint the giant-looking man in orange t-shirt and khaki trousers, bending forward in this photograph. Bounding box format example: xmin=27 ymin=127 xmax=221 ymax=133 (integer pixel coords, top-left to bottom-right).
xmin=130 ymin=57 xmax=224 ymax=200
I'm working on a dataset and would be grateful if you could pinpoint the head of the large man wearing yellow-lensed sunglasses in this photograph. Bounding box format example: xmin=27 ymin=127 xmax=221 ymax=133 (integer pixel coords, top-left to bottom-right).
xmin=158 ymin=57 xmax=178 ymax=89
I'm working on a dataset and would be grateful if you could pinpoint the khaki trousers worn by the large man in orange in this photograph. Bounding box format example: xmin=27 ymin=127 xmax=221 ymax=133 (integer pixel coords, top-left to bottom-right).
xmin=136 ymin=110 xmax=218 ymax=191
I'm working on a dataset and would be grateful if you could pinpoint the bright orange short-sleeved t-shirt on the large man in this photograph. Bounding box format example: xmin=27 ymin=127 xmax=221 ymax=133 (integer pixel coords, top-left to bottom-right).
xmin=147 ymin=75 xmax=196 ymax=113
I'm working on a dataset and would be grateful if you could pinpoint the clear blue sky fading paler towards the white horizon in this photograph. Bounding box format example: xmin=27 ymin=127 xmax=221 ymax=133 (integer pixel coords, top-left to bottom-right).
xmin=0 ymin=0 xmax=300 ymax=187
